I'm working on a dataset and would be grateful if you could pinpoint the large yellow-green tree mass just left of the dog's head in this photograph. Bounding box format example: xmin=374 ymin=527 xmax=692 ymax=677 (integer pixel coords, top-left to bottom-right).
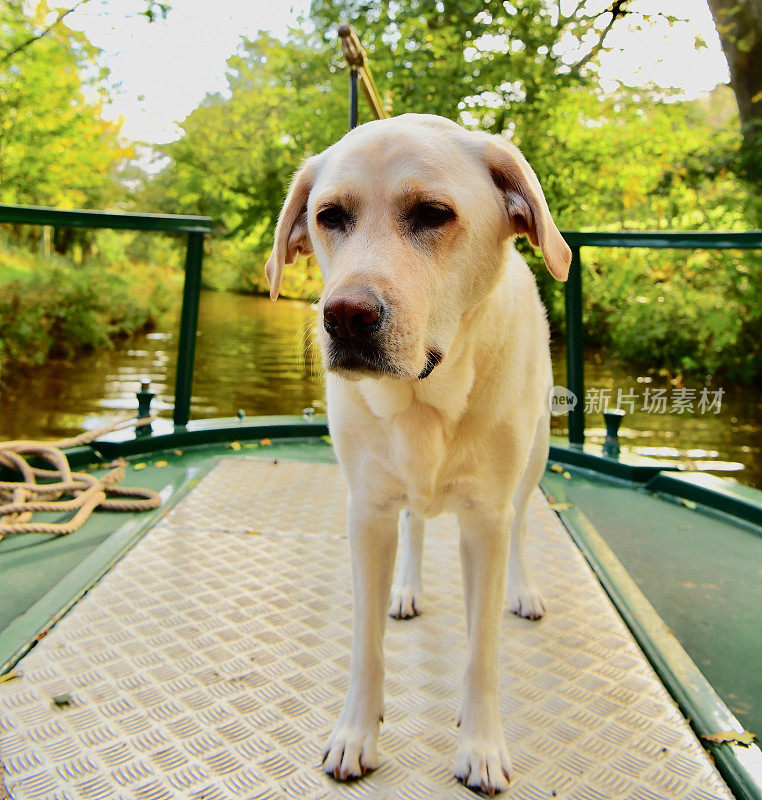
xmin=139 ymin=32 xmax=349 ymax=296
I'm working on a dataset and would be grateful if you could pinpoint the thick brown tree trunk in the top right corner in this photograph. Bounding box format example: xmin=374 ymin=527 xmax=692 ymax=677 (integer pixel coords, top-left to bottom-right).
xmin=708 ymin=0 xmax=762 ymax=189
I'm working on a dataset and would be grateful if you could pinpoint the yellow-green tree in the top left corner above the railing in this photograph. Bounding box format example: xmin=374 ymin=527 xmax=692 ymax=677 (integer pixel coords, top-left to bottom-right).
xmin=0 ymin=0 xmax=132 ymax=208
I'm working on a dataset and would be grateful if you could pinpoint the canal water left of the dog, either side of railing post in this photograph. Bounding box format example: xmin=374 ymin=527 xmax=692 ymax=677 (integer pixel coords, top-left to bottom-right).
xmin=0 ymin=292 xmax=325 ymax=439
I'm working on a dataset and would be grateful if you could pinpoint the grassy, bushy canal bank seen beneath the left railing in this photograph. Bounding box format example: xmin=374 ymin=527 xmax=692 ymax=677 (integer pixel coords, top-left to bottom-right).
xmin=0 ymin=246 xmax=182 ymax=380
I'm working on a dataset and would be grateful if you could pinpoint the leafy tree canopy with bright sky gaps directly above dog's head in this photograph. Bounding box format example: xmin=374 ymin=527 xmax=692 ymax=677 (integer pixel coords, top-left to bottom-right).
xmin=310 ymin=0 xmax=652 ymax=133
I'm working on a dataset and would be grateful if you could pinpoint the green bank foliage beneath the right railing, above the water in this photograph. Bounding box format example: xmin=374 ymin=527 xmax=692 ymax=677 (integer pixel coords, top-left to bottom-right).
xmin=583 ymin=248 xmax=762 ymax=381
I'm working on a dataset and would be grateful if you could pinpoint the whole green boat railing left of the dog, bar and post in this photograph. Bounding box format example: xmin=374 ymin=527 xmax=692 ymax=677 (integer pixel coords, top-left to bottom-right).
xmin=0 ymin=205 xmax=212 ymax=427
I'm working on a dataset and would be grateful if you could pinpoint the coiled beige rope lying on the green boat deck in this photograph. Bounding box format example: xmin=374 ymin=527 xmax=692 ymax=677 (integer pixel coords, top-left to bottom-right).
xmin=0 ymin=415 xmax=161 ymax=539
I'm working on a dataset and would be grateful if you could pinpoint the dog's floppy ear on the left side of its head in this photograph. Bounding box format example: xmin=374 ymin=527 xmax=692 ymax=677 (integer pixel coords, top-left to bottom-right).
xmin=265 ymin=156 xmax=320 ymax=300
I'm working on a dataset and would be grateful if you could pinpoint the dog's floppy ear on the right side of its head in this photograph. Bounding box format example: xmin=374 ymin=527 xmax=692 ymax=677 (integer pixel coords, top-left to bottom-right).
xmin=484 ymin=136 xmax=571 ymax=281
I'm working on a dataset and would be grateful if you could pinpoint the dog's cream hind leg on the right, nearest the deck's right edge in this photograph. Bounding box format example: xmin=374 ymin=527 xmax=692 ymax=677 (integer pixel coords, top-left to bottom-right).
xmin=508 ymin=416 xmax=550 ymax=619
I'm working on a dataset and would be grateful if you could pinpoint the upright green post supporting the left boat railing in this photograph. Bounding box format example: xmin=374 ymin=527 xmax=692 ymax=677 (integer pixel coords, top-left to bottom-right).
xmin=173 ymin=233 xmax=204 ymax=426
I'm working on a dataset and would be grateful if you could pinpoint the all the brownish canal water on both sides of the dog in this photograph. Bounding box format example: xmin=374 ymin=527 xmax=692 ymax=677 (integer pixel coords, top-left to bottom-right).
xmin=0 ymin=292 xmax=762 ymax=488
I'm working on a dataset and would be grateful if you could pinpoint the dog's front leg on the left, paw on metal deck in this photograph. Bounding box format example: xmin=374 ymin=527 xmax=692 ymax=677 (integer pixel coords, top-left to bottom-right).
xmin=323 ymin=497 xmax=399 ymax=780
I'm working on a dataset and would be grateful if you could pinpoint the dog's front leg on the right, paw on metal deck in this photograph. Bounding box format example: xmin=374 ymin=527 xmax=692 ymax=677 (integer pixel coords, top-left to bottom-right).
xmin=455 ymin=508 xmax=511 ymax=794
